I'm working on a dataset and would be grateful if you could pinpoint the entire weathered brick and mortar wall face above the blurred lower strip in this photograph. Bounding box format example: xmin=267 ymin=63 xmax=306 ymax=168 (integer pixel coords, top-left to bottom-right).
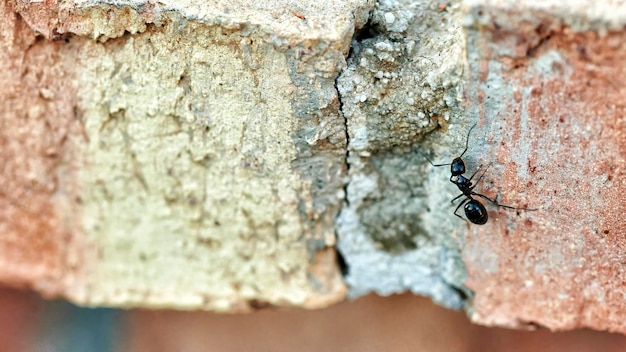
xmin=0 ymin=0 xmax=626 ymax=332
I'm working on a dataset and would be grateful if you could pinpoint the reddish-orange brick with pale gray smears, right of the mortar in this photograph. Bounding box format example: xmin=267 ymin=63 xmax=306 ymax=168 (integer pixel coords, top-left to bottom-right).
xmin=462 ymin=2 xmax=626 ymax=333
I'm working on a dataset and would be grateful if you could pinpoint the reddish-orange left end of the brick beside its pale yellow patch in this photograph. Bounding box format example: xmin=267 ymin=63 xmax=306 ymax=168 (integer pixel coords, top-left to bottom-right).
xmin=0 ymin=2 xmax=88 ymax=292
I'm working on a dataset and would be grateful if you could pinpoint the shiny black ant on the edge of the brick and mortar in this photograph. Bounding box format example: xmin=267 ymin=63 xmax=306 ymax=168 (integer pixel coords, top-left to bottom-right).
xmin=424 ymin=124 xmax=537 ymax=225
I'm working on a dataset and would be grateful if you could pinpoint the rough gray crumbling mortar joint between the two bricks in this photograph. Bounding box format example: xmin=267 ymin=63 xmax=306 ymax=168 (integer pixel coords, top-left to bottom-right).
xmin=337 ymin=1 xmax=471 ymax=308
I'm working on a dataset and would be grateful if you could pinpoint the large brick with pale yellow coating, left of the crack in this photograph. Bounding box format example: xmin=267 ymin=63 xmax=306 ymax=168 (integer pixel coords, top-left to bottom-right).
xmin=0 ymin=1 xmax=376 ymax=311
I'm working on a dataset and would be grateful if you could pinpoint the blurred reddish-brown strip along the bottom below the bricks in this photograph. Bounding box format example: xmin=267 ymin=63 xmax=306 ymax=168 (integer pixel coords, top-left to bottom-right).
xmin=0 ymin=289 xmax=626 ymax=352
